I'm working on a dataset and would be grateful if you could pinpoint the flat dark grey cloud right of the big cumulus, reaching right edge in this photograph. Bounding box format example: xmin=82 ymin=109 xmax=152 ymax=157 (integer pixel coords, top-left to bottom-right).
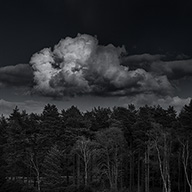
xmin=123 ymin=54 xmax=192 ymax=80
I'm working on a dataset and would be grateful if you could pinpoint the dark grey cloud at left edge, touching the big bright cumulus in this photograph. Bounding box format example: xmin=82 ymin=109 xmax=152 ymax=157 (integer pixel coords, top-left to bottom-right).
xmin=0 ymin=64 xmax=33 ymax=87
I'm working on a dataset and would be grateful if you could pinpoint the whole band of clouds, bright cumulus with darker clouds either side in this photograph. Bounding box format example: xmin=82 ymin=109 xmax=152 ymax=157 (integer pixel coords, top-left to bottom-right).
xmin=0 ymin=34 xmax=192 ymax=110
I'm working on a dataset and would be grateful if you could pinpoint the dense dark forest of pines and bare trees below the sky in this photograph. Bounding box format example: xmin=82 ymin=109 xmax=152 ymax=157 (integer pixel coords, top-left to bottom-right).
xmin=0 ymin=101 xmax=192 ymax=192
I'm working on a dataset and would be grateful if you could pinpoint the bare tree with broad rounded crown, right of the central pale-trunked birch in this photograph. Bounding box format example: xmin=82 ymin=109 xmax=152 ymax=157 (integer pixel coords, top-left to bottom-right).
xmin=97 ymin=127 xmax=125 ymax=190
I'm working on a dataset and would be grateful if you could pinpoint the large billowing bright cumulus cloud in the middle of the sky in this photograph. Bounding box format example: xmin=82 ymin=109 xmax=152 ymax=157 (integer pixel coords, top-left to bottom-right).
xmin=30 ymin=34 xmax=172 ymax=97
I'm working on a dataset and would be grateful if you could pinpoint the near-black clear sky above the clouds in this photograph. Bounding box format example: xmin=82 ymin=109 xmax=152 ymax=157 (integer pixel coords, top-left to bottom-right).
xmin=0 ymin=0 xmax=192 ymax=115
